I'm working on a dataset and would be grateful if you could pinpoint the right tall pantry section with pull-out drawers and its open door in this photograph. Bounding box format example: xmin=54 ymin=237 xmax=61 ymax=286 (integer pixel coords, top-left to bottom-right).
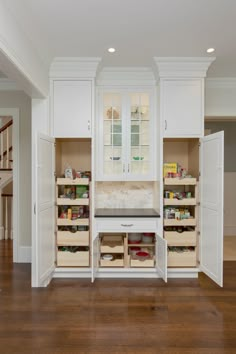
xmin=163 ymin=132 xmax=224 ymax=286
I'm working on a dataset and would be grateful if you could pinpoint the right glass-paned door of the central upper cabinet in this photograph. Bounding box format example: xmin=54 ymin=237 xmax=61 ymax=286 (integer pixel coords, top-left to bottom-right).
xmin=127 ymin=93 xmax=151 ymax=176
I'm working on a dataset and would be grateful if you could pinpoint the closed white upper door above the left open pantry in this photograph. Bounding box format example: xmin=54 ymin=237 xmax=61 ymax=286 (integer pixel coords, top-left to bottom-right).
xmin=52 ymin=80 xmax=92 ymax=138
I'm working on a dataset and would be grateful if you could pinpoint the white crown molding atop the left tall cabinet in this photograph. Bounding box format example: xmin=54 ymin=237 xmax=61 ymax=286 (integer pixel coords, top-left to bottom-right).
xmin=49 ymin=57 xmax=101 ymax=79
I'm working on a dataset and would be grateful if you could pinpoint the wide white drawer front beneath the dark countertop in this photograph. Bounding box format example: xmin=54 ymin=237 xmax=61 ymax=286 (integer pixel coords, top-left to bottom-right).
xmin=96 ymin=218 xmax=158 ymax=232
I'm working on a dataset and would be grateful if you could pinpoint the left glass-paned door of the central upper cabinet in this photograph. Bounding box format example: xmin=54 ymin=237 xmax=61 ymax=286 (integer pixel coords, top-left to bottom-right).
xmin=103 ymin=93 xmax=124 ymax=176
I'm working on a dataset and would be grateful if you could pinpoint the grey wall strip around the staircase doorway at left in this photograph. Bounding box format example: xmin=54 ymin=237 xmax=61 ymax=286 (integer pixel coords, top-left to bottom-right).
xmin=0 ymin=91 xmax=31 ymax=247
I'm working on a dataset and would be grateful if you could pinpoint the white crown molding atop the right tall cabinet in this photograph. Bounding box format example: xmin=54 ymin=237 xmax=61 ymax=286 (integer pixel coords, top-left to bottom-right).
xmin=154 ymin=57 xmax=215 ymax=78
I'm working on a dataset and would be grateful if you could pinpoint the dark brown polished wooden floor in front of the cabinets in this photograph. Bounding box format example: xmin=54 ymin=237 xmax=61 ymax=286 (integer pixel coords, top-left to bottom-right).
xmin=0 ymin=241 xmax=236 ymax=354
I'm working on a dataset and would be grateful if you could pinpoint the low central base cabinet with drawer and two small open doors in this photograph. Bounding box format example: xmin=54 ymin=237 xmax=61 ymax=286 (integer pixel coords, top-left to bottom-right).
xmin=91 ymin=217 xmax=167 ymax=282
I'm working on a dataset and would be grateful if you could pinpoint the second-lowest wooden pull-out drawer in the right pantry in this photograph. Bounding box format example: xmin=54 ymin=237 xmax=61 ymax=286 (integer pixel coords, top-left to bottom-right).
xmin=164 ymin=231 xmax=197 ymax=246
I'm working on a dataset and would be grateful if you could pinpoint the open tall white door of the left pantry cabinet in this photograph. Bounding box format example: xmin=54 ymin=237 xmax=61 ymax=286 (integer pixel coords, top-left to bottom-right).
xmin=32 ymin=134 xmax=55 ymax=287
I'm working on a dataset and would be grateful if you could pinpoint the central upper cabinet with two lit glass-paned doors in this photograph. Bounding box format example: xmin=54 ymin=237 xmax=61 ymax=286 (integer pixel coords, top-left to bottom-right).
xmin=96 ymin=89 xmax=156 ymax=181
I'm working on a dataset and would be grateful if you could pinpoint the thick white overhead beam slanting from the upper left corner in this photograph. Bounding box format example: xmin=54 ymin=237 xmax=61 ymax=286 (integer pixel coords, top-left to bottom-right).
xmin=0 ymin=2 xmax=49 ymax=98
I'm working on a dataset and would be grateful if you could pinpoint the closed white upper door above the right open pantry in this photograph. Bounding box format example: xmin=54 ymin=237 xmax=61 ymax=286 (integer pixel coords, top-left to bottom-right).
xmin=161 ymin=78 xmax=204 ymax=137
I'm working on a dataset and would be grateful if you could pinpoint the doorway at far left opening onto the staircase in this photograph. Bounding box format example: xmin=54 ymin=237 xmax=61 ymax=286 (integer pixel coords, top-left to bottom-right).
xmin=0 ymin=108 xmax=19 ymax=263
